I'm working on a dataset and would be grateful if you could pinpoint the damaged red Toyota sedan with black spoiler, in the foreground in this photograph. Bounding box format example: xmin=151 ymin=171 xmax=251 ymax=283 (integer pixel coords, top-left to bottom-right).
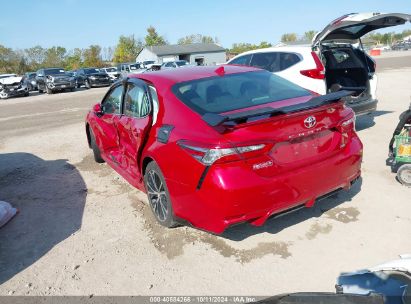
xmin=86 ymin=65 xmax=362 ymax=233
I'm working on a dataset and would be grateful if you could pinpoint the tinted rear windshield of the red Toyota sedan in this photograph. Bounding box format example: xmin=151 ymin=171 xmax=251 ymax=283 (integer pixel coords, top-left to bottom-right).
xmin=173 ymin=71 xmax=311 ymax=115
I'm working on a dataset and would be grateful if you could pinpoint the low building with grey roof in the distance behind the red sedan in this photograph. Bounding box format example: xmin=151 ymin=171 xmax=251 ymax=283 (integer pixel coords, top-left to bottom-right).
xmin=136 ymin=43 xmax=226 ymax=65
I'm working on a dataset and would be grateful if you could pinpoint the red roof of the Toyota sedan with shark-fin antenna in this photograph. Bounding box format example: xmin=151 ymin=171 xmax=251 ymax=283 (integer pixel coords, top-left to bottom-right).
xmin=129 ymin=65 xmax=263 ymax=85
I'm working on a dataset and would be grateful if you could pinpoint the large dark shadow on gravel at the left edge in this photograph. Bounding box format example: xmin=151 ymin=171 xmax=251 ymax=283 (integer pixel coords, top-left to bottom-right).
xmin=0 ymin=153 xmax=87 ymax=285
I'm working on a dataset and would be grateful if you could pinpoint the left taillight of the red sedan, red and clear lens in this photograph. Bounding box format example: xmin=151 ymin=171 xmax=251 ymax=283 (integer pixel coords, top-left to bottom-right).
xmin=178 ymin=140 xmax=272 ymax=166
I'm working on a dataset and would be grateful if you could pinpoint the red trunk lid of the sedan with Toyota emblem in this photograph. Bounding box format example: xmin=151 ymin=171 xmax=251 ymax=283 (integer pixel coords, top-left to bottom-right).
xmin=206 ymin=92 xmax=353 ymax=177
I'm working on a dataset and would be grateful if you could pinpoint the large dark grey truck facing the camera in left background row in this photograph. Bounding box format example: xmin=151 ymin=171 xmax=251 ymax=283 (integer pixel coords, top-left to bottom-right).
xmin=36 ymin=68 xmax=76 ymax=94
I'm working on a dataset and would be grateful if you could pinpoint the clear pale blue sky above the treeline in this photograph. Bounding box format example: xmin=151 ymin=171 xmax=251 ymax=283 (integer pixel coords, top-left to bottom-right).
xmin=0 ymin=0 xmax=411 ymax=49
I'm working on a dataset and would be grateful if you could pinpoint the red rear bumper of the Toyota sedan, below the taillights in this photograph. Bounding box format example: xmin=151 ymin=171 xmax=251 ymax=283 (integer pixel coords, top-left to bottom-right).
xmin=167 ymin=137 xmax=362 ymax=233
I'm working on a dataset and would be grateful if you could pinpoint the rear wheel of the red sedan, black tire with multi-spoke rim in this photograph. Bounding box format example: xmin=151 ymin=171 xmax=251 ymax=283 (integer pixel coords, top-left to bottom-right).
xmin=144 ymin=161 xmax=178 ymax=228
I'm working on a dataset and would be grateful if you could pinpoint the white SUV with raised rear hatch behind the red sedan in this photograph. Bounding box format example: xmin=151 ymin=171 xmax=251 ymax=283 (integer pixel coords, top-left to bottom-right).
xmin=228 ymin=13 xmax=411 ymax=115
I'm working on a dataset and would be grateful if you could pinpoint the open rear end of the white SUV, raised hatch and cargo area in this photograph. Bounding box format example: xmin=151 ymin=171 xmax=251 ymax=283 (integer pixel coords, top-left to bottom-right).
xmin=312 ymin=13 xmax=411 ymax=115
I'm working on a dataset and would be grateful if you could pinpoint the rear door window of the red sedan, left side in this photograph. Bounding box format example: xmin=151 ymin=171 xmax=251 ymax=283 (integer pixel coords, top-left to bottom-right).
xmin=123 ymin=83 xmax=150 ymax=117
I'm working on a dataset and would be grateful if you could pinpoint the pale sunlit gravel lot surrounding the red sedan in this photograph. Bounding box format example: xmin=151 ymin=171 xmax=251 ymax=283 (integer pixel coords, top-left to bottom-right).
xmin=0 ymin=57 xmax=411 ymax=295
